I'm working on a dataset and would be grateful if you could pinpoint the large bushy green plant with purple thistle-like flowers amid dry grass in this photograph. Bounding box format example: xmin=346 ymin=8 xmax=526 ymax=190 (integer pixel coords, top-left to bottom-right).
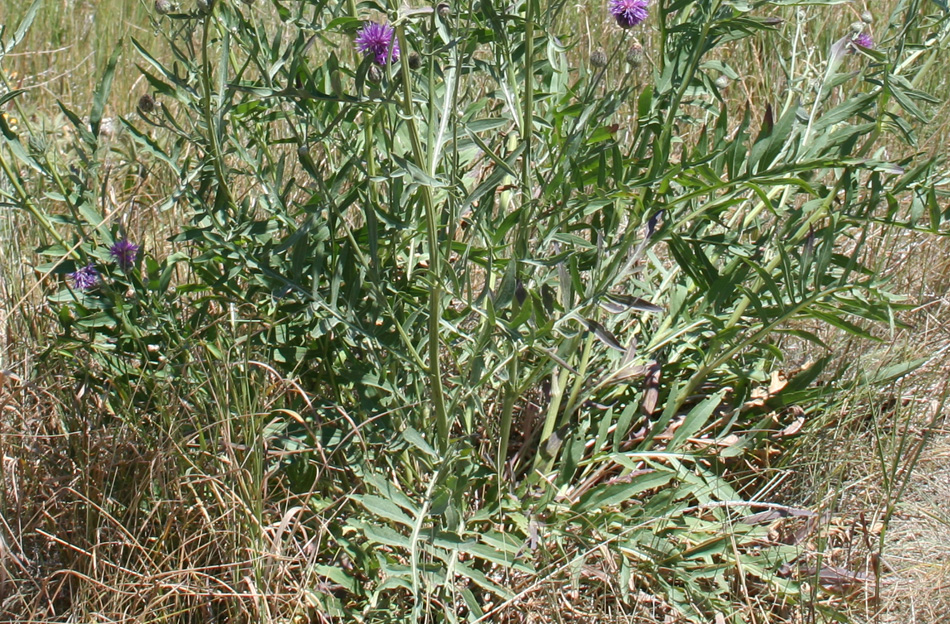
xmin=3 ymin=0 xmax=947 ymax=622
